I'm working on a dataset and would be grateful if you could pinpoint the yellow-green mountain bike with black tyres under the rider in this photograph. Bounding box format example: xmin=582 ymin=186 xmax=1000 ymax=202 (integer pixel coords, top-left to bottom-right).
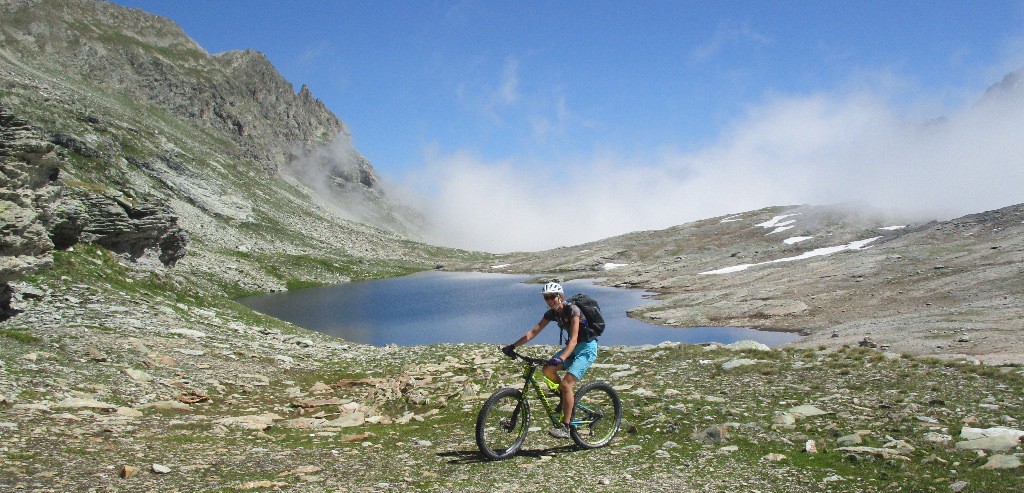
xmin=476 ymin=352 xmax=623 ymax=460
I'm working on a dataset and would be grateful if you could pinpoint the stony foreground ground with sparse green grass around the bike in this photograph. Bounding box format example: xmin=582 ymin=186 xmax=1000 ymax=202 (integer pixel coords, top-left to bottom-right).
xmin=0 ymin=252 xmax=1024 ymax=492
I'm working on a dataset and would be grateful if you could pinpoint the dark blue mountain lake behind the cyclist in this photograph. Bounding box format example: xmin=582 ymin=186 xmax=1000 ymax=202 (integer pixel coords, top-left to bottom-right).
xmin=239 ymin=272 xmax=797 ymax=345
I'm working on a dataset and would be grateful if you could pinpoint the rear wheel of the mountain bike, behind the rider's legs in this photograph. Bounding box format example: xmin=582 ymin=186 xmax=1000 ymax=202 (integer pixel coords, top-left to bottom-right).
xmin=569 ymin=381 xmax=623 ymax=449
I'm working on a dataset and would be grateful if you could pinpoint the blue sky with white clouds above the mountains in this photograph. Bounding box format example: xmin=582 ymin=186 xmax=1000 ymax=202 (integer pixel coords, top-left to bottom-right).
xmin=116 ymin=0 xmax=1024 ymax=251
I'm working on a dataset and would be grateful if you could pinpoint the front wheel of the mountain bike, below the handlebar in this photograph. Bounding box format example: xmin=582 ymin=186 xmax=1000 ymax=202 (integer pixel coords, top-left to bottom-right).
xmin=476 ymin=387 xmax=529 ymax=460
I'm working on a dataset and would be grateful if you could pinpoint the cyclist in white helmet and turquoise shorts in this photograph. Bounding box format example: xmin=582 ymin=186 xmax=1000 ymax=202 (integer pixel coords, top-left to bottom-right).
xmin=502 ymin=283 xmax=597 ymax=439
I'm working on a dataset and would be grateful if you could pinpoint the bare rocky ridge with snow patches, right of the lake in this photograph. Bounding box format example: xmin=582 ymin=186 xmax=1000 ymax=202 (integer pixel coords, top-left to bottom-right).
xmin=460 ymin=200 xmax=1024 ymax=364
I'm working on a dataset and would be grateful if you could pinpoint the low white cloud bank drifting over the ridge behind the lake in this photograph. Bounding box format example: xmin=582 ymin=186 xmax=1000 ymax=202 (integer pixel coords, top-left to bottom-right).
xmin=407 ymin=73 xmax=1024 ymax=252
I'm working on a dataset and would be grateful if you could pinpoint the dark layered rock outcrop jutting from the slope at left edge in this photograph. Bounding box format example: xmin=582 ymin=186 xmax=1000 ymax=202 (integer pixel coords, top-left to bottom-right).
xmin=0 ymin=106 xmax=188 ymax=319
